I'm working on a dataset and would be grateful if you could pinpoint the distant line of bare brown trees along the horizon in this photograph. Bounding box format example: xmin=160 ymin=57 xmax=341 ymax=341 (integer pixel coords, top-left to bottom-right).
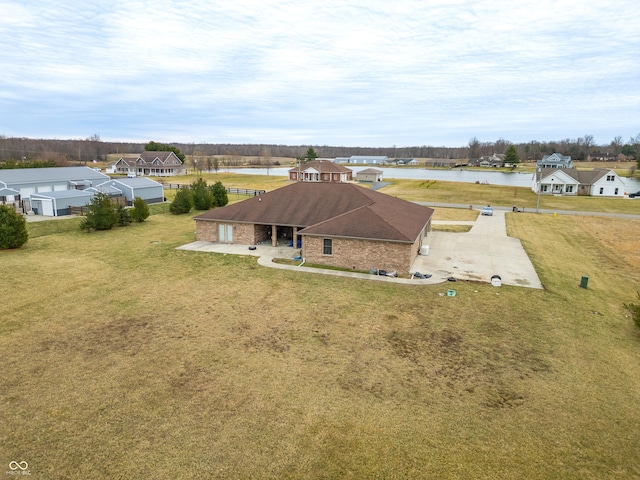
xmin=0 ymin=134 xmax=640 ymax=168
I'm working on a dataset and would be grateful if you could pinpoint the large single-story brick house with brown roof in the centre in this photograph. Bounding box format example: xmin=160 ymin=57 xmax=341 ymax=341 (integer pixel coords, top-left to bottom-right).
xmin=194 ymin=182 xmax=433 ymax=272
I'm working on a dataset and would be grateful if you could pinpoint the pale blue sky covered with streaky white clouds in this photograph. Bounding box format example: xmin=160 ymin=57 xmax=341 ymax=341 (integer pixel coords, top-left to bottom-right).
xmin=0 ymin=0 xmax=640 ymax=147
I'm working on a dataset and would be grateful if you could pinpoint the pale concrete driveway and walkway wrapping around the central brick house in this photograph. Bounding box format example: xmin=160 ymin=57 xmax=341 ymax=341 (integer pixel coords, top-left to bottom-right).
xmin=178 ymin=209 xmax=543 ymax=289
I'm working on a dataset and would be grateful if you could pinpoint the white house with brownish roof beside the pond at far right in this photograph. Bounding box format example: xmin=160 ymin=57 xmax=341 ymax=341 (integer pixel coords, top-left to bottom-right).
xmin=531 ymin=167 xmax=625 ymax=197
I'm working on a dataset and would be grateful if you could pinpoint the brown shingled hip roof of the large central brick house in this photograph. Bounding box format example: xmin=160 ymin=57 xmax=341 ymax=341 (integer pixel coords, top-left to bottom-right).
xmin=194 ymin=182 xmax=433 ymax=242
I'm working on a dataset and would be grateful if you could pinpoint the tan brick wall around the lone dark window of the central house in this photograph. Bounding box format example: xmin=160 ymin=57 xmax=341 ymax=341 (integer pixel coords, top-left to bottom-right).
xmin=302 ymin=235 xmax=420 ymax=273
